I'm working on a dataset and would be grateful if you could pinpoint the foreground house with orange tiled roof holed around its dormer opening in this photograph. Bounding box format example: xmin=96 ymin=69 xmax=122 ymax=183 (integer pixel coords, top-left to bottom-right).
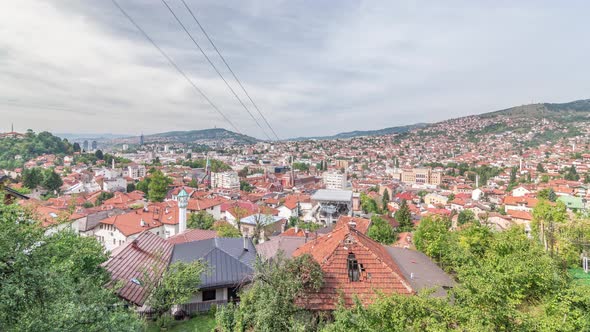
xmin=293 ymin=222 xmax=454 ymax=311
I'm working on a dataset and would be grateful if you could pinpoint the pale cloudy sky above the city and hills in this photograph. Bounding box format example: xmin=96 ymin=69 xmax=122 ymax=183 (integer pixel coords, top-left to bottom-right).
xmin=0 ymin=0 xmax=590 ymax=139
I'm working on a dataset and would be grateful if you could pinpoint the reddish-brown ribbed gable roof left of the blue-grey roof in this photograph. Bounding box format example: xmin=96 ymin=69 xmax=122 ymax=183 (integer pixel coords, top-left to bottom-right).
xmin=103 ymin=231 xmax=172 ymax=306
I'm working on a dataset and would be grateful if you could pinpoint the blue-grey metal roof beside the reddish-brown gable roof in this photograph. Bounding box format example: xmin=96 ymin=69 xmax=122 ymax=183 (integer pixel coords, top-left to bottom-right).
xmin=170 ymin=238 xmax=256 ymax=288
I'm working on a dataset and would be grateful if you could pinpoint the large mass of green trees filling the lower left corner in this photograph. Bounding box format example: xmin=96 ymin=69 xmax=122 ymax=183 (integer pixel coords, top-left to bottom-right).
xmin=0 ymin=200 xmax=140 ymax=331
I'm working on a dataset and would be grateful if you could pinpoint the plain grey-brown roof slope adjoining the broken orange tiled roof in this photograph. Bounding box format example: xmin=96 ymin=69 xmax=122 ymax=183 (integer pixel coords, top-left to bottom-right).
xmin=385 ymin=246 xmax=455 ymax=297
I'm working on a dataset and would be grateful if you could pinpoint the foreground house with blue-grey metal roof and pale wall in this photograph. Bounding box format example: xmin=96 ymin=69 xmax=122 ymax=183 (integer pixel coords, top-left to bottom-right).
xmin=170 ymin=238 xmax=256 ymax=315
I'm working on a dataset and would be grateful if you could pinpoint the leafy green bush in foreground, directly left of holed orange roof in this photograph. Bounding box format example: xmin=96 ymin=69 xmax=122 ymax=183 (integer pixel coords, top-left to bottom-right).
xmin=215 ymin=255 xmax=324 ymax=332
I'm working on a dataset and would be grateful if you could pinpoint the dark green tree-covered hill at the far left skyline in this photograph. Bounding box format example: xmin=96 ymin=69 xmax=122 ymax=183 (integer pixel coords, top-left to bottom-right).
xmin=0 ymin=130 xmax=73 ymax=169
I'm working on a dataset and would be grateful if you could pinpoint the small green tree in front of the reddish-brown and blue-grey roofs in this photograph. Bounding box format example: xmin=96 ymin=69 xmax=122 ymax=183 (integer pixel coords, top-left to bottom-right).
xmin=146 ymin=260 xmax=207 ymax=315
